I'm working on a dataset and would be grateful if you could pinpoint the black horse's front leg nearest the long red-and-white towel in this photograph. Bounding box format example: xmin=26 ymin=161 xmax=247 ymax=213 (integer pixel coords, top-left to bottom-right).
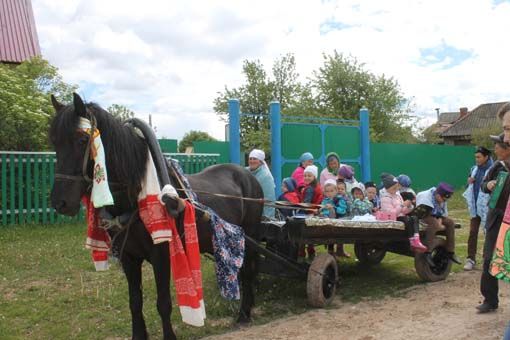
xmin=151 ymin=242 xmax=176 ymax=340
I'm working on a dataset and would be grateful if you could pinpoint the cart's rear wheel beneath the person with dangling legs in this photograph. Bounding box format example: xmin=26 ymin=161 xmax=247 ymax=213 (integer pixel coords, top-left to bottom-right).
xmin=414 ymin=237 xmax=452 ymax=282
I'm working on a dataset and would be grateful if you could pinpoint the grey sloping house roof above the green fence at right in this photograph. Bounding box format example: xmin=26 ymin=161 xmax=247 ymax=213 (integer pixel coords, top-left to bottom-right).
xmin=441 ymin=102 xmax=506 ymax=137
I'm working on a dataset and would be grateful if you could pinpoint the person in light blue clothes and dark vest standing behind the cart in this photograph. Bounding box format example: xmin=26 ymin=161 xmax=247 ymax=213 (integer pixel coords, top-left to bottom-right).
xmin=462 ymin=146 xmax=492 ymax=270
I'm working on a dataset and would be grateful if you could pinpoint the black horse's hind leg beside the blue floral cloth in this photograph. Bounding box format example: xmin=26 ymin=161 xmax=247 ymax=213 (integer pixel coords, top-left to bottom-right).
xmin=237 ymin=246 xmax=257 ymax=324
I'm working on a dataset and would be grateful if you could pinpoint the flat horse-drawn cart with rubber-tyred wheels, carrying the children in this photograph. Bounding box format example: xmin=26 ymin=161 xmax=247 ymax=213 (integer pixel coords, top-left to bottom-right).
xmin=247 ymin=217 xmax=459 ymax=307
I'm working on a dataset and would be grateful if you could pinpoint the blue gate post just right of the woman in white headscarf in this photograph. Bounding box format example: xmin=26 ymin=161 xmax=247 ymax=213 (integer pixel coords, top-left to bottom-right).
xmin=269 ymin=101 xmax=282 ymax=197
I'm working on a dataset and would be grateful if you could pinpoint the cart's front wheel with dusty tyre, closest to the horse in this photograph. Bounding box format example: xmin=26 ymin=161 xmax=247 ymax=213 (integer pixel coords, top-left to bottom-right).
xmin=306 ymin=254 xmax=338 ymax=307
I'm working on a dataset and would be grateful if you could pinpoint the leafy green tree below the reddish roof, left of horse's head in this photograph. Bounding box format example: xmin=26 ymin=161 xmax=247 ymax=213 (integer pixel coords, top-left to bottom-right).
xmin=0 ymin=57 xmax=77 ymax=151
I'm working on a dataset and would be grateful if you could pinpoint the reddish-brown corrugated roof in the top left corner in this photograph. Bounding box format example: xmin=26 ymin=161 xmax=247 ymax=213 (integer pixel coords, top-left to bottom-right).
xmin=0 ymin=0 xmax=41 ymax=63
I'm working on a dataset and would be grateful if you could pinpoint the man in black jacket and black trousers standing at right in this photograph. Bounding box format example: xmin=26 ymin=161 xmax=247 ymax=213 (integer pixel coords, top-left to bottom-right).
xmin=476 ymin=134 xmax=510 ymax=313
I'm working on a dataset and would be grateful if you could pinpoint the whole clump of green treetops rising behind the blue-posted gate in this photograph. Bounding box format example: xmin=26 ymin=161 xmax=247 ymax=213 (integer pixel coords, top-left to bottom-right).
xmin=214 ymin=51 xmax=418 ymax=153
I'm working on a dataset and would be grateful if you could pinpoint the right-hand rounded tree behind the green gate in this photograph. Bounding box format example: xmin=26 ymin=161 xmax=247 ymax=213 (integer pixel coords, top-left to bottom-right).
xmin=311 ymin=51 xmax=417 ymax=143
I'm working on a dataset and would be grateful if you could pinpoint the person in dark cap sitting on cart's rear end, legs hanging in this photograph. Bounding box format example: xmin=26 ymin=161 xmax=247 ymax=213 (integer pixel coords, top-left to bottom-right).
xmin=414 ymin=182 xmax=461 ymax=266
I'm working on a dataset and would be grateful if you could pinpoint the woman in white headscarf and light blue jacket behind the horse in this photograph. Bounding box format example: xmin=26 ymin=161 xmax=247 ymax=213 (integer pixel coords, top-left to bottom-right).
xmin=246 ymin=149 xmax=276 ymax=218
